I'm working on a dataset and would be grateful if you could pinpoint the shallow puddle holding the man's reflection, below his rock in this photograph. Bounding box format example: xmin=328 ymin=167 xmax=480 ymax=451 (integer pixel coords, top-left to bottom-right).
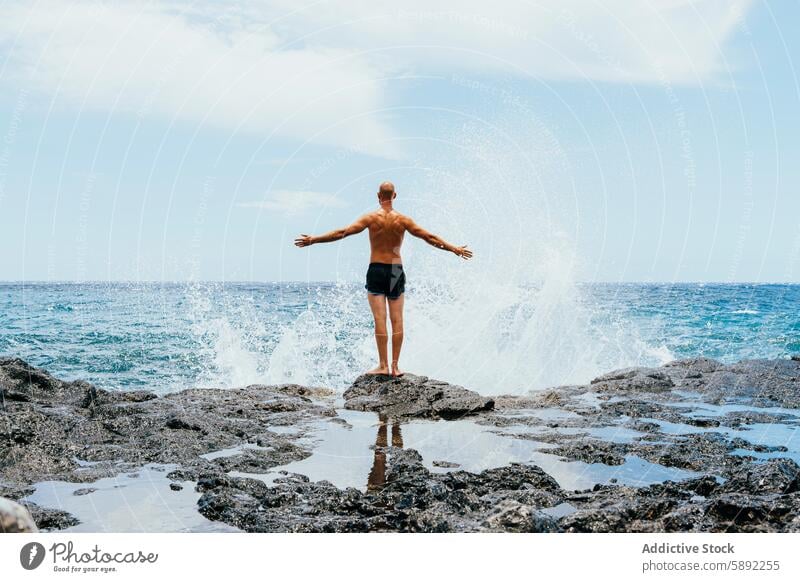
xmin=230 ymin=410 xmax=695 ymax=498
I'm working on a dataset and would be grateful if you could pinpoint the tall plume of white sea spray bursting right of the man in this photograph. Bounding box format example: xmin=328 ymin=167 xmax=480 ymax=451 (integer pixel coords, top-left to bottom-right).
xmin=384 ymin=122 xmax=671 ymax=394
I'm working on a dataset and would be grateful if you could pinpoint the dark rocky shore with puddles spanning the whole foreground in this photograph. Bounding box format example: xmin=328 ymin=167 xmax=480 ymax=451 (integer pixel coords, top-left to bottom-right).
xmin=0 ymin=358 xmax=800 ymax=532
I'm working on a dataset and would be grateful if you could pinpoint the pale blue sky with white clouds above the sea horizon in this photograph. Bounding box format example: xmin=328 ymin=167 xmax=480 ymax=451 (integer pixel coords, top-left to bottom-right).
xmin=0 ymin=0 xmax=800 ymax=282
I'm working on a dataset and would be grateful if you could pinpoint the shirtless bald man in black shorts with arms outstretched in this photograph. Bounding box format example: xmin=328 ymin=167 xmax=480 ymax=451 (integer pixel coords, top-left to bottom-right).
xmin=294 ymin=182 xmax=472 ymax=376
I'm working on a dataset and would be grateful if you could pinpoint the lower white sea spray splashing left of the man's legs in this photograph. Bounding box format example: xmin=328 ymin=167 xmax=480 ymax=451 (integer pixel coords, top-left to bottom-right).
xmin=187 ymin=284 xmax=374 ymax=388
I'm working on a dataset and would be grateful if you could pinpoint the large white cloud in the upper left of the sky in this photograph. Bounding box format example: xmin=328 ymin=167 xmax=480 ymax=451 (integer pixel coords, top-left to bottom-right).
xmin=0 ymin=1 xmax=396 ymax=156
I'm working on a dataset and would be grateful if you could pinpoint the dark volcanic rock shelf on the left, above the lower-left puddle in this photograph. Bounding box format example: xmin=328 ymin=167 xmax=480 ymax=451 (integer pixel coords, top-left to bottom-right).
xmin=0 ymin=359 xmax=335 ymax=500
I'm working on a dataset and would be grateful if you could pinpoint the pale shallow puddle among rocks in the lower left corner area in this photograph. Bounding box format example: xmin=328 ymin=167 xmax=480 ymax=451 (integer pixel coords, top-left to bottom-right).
xmin=22 ymin=465 xmax=238 ymax=533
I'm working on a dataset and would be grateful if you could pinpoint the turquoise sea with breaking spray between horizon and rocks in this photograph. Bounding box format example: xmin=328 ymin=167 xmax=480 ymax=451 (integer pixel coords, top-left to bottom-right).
xmin=0 ymin=283 xmax=800 ymax=393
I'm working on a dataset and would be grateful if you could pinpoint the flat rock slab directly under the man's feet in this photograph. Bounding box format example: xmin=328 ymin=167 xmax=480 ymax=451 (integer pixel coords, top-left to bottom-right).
xmin=344 ymin=374 xmax=494 ymax=420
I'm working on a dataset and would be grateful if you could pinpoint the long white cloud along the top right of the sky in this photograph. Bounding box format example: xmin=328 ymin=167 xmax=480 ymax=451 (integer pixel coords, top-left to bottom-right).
xmin=264 ymin=0 xmax=752 ymax=83
